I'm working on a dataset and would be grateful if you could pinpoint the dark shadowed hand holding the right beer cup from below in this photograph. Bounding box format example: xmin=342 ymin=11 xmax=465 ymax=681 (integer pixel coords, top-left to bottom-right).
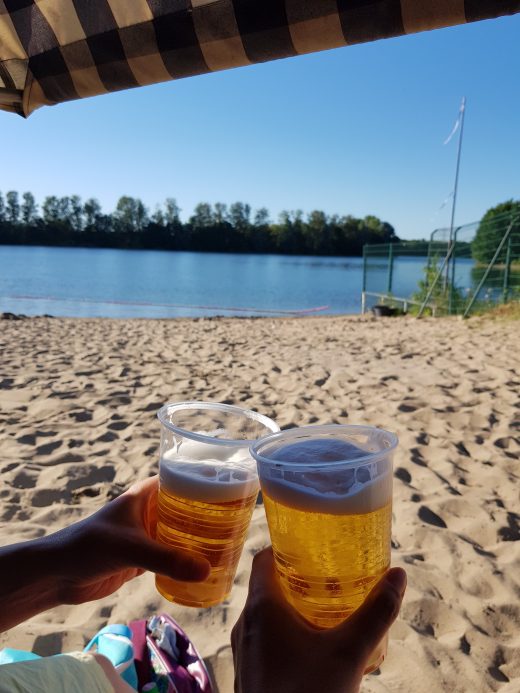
xmin=231 ymin=549 xmax=406 ymax=693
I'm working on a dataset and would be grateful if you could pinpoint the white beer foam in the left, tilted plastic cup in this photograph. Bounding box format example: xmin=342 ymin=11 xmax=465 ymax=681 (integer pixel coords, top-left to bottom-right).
xmin=159 ymin=441 xmax=259 ymax=503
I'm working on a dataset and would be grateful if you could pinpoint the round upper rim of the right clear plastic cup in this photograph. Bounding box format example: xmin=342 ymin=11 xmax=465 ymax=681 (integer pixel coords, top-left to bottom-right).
xmin=249 ymin=424 xmax=399 ymax=472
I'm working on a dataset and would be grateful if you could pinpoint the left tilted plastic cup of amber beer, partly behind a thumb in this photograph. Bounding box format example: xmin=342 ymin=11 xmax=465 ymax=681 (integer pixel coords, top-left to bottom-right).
xmin=156 ymin=402 xmax=280 ymax=607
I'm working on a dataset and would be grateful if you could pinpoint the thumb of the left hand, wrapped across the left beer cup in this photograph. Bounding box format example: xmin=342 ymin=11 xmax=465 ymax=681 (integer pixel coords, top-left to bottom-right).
xmin=125 ymin=538 xmax=210 ymax=582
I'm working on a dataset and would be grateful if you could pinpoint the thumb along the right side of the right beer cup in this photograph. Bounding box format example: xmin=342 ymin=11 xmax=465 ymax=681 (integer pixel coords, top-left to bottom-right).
xmin=336 ymin=568 xmax=406 ymax=659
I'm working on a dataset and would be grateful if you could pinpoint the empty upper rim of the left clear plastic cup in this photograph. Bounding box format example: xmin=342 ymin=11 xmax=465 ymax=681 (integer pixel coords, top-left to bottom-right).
xmin=157 ymin=400 xmax=280 ymax=448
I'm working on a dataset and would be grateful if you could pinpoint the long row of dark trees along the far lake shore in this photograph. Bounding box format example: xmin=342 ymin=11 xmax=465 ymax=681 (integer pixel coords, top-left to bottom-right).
xmin=0 ymin=190 xmax=399 ymax=255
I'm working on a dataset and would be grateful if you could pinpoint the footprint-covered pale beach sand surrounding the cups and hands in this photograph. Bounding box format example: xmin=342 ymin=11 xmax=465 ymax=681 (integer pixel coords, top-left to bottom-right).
xmin=0 ymin=316 xmax=520 ymax=693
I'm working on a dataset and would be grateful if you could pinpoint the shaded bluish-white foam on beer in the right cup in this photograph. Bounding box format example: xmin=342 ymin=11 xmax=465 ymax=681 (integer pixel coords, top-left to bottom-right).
xmin=260 ymin=438 xmax=392 ymax=514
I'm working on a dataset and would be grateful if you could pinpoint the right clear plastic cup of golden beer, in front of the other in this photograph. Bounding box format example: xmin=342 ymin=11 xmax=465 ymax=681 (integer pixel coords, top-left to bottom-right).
xmin=251 ymin=425 xmax=397 ymax=671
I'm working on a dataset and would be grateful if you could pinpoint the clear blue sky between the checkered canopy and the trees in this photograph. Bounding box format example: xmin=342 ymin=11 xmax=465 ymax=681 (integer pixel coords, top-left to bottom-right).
xmin=0 ymin=15 xmax=520 ymax=238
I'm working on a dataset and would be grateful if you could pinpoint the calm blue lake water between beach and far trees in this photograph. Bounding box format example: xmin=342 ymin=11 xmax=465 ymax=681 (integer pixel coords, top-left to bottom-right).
xmin=0 ymin=246 xmax=476 ymax=318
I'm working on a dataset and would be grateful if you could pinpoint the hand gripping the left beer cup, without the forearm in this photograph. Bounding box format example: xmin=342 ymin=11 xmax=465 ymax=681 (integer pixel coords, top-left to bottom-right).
xmin=41 ymin=476 xmax=209 ymax=604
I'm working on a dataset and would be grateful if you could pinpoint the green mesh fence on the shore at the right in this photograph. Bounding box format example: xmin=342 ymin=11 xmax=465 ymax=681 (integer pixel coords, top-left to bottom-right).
xmin=362 ymin=212 xmax=520 ymax=317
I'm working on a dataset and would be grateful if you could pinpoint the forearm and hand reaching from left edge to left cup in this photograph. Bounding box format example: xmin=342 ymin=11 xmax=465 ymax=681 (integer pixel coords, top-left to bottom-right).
xmin=0 ymin=477 xmax=209 ymax=632
